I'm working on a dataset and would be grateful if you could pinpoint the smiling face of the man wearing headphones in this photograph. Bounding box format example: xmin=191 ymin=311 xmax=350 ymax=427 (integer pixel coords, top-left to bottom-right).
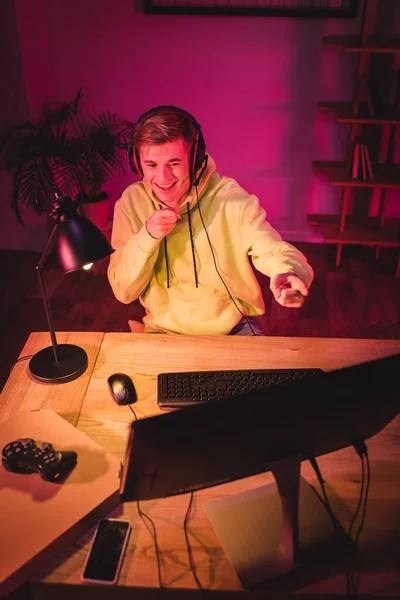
xmin=139 ymin=138 xmax=190 ymax=208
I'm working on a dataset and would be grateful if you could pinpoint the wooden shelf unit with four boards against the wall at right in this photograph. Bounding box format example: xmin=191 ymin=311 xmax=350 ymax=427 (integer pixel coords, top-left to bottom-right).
xmin=307 ymin=0 xmax=400 ymax=276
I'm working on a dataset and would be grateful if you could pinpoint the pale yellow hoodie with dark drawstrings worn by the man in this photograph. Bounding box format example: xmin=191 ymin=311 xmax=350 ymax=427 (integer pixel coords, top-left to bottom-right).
xmin=108 ymin=157 xmax=313 ymax=335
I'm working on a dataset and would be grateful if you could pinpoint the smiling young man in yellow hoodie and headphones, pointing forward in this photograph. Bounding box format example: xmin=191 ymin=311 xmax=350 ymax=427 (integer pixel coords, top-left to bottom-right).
xmin=108 ymin=106 xmax=313 ymax=335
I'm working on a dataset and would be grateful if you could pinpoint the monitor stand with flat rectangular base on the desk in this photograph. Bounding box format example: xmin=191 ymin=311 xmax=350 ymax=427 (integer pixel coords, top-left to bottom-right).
xmin=205 ymin=456 xmax=351 ymax=588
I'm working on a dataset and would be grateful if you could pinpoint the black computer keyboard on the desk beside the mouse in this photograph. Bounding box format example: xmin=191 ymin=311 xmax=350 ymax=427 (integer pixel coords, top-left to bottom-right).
xmin=157 ymin=368 xmax=323 ymax=408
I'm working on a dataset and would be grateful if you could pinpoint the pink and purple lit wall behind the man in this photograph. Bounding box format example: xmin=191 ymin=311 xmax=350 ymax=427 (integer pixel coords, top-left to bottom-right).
xmin=0 ymin=0 xmax=400 ymax=249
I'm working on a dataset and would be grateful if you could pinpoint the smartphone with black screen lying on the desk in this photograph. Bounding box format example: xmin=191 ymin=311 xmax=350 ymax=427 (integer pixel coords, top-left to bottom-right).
xmin=81 ymin=519 xmax=132 ymax=585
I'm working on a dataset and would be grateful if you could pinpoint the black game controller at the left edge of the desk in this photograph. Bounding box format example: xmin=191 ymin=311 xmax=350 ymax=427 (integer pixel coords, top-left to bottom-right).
xmin=1 ymin=438 xmax=77 ymax=481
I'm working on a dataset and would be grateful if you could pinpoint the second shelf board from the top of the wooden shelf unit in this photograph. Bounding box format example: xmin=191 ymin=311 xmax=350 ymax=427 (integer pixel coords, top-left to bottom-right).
xmin=318 ymin=101 xmax=400 ymax=125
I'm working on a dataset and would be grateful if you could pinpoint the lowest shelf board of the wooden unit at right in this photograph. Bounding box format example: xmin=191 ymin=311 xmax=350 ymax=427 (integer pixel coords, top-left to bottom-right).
xmin=307 ymin=214 xmax=400 ymax=248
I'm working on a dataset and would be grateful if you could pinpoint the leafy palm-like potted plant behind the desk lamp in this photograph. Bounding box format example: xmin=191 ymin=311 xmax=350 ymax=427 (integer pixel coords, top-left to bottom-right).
xmin=0 ymin=88 xmax=132 ymax=229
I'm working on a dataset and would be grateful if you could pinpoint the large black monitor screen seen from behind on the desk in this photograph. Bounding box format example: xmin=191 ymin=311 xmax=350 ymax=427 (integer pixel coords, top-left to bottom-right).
xmin=120 ymin=354 xmax=400 ymax=501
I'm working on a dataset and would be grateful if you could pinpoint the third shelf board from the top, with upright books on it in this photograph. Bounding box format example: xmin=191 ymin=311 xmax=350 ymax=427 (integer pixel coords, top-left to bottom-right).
xmin=312 ymin=160 xmax=400 ymax=188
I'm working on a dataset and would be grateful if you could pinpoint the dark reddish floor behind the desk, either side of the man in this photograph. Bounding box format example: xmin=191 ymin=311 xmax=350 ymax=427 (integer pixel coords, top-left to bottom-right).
xmin=0 ymin=243 xmax=400 ymax=389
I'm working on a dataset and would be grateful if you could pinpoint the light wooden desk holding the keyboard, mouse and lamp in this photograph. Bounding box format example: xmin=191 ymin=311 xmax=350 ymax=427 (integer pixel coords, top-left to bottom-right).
xmin=0 ymin=333 xmax=400 ymax=600
